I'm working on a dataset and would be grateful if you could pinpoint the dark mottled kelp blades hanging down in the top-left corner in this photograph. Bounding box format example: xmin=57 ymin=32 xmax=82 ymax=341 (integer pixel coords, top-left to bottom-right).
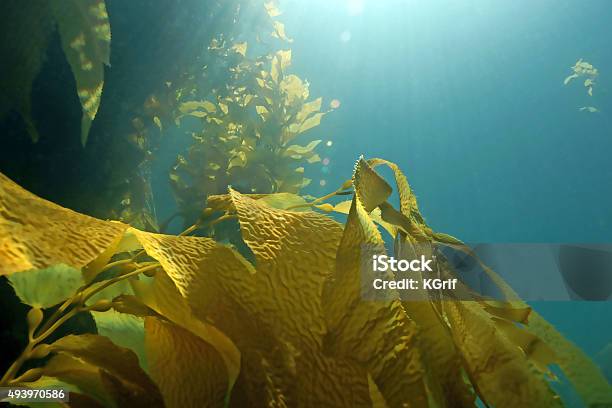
xmin=0 ymin=0 xmax=111 ymax=145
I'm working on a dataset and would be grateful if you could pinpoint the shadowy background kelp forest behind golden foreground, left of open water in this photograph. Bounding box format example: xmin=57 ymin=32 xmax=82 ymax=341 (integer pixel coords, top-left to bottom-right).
xmin=0 ymin=0 xmax=326 ymax=231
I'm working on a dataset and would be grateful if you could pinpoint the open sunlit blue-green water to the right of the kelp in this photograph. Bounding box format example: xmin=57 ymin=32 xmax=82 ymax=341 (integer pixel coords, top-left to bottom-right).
xmin=283 ymin=0 xmax=612 ymax=372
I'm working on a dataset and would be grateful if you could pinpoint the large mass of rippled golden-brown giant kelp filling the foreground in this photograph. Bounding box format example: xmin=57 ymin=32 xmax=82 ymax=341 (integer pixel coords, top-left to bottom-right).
xmin=0 ymin=159 xmax=612 ymax=407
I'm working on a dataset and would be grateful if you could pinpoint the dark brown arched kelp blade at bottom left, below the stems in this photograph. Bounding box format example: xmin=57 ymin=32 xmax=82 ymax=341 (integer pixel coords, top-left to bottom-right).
xmin=51 ymin=334 xmax=163 ymax=406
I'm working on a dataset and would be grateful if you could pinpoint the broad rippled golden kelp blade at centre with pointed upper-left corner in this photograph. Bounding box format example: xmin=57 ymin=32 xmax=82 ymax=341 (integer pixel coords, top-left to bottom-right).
xmin=230 ymin=190 xmax=342 ymax=349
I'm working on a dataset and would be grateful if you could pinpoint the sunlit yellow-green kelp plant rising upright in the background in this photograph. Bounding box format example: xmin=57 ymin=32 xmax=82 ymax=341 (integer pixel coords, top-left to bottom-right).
xmin=170 ymin=2 xmax=325 ymax=226
